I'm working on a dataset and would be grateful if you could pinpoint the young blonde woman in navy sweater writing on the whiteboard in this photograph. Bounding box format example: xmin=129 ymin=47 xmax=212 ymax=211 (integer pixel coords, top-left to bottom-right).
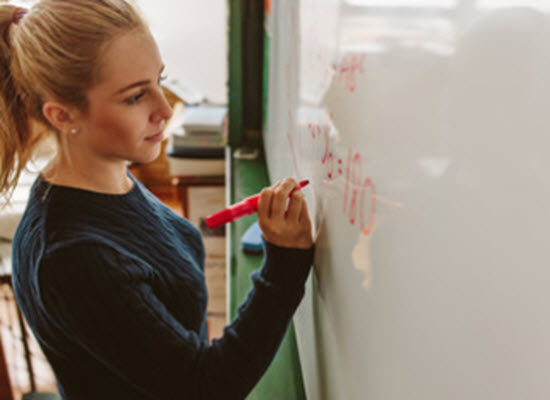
xmin=0 ymin=0 xmax=313 ymax=400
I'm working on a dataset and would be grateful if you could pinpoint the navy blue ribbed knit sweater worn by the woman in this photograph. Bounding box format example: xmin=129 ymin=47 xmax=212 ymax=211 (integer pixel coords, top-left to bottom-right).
xmin=13 ymin=173 xmax=313 ymax=400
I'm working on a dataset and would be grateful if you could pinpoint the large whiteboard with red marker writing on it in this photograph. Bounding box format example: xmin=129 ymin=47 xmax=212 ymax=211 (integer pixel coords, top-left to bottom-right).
xmin=264 ymin=0 xmax=550 ymax=400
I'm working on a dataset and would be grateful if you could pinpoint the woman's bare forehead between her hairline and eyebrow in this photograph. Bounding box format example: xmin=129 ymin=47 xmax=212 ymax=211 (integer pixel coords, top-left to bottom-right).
xmin=95 ymin=31 xmax=162 ymax=94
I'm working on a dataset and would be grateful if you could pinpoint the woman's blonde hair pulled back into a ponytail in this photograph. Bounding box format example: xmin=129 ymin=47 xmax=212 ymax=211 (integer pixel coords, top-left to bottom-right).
xmin=0 ymin=0 xmax=148 ymax=203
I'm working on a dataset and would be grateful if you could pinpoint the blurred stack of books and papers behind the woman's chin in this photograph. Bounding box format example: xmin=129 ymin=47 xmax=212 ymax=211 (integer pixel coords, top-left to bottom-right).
xmin=166 ymin=105 xmax=227 ymax=175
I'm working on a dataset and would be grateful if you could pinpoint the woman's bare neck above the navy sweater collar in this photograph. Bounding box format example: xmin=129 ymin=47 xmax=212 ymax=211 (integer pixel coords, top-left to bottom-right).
xmin=43 ymin=155 xmax=133 ymax=194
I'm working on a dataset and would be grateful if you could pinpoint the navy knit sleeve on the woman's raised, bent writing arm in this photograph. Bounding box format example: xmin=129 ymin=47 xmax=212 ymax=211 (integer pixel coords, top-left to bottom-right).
xmin=40 ymin=242 xmax=313 ymax=399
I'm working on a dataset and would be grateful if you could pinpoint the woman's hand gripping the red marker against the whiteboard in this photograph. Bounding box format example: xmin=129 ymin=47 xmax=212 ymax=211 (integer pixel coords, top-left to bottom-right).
xmin=258 ymin=178 xmax=313 ymax=249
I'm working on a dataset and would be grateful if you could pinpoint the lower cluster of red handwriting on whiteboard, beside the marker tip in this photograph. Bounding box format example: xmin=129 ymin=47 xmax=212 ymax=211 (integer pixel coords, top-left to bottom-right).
xmin=308 ymin=119 xmax=376 ymax=236
